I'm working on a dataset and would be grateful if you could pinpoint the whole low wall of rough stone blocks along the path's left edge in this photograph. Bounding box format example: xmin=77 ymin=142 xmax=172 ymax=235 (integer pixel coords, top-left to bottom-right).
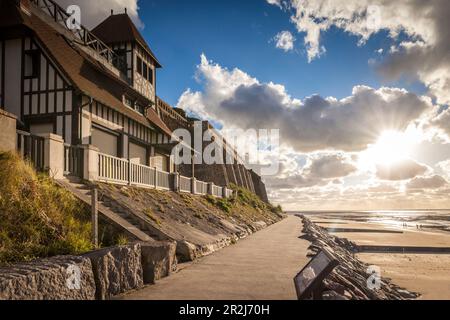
xmin=0 ymin=242 xmax=177 ymax=300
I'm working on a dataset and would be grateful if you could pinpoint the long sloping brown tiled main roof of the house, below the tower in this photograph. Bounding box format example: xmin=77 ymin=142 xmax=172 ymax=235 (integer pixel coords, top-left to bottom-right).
xmin=0 ymin=1 xmax=172 ymax=136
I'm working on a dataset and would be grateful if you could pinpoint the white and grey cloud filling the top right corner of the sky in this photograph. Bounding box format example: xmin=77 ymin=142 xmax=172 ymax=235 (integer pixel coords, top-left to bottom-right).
xmin=269 ymin=0 xmax=450 ymax=104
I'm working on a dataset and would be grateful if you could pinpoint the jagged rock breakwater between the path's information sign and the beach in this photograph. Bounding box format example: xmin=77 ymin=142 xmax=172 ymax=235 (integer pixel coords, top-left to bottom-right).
xmin=300 ymin=216 xmax=419 ymax=300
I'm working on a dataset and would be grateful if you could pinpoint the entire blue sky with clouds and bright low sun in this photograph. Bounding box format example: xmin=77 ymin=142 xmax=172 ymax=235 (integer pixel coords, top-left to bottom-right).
xmin=59 ymin=0 xmax=450 ymax=210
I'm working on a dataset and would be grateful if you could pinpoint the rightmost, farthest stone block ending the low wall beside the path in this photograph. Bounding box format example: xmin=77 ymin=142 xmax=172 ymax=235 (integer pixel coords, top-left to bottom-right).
xmin=141 ymin=241 xmax=177 ymax=284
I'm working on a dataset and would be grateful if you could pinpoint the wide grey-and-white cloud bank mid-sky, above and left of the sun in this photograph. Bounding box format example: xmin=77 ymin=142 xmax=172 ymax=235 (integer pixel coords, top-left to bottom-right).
xmin=177 ymin=55 xmax=432 ymax=152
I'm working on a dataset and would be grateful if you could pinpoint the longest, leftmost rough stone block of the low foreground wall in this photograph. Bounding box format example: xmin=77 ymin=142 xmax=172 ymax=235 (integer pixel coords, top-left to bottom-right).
xmin=0 ymin=256 xmax=95 ymax=300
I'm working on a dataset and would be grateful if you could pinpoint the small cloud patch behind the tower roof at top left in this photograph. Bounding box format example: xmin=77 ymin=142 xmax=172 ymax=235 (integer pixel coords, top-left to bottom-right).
xmin=56 ymin=0 xmax=144 ymax=29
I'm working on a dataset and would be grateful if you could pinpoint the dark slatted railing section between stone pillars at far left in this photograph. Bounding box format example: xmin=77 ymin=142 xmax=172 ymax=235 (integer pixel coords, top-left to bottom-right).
xmin=17 ymin=131 xmax=45 ymax=171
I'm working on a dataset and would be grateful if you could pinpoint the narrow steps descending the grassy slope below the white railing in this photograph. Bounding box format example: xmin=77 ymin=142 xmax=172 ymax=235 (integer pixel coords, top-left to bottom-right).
xmin=56 ymin=179 xmax=154 ymax=241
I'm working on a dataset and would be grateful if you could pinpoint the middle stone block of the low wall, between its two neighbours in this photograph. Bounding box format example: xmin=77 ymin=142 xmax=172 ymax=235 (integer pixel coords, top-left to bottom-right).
xmin=85 ymin=243 xmax=144 ymax=300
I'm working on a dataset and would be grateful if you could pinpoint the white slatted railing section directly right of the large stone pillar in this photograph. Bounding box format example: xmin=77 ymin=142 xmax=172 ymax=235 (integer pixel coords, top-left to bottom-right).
xmin=98 ymin=153 xmax=130 ymax=184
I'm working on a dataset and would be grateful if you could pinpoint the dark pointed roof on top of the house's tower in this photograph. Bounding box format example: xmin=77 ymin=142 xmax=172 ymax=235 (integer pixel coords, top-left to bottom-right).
xmin=92 ymin=13 xmax=161 ymax=68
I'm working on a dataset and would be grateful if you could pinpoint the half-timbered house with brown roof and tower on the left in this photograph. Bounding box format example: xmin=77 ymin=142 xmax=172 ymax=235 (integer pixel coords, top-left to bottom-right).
xmin=0 ymin=0 xmax=174 ymax=172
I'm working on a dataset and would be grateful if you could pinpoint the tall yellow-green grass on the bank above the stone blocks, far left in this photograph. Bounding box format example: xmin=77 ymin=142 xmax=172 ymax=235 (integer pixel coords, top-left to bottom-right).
xmin=0 ymin=152 xmax=93 ymax=264
